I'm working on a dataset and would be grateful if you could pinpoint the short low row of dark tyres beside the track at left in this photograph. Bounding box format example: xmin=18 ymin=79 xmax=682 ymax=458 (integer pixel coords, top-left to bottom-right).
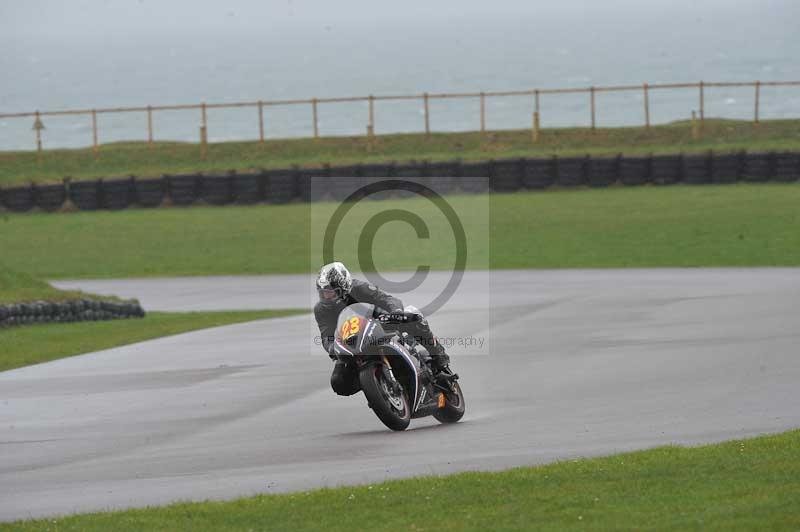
xmin=0 ymin=299 xmax=145 ymax=328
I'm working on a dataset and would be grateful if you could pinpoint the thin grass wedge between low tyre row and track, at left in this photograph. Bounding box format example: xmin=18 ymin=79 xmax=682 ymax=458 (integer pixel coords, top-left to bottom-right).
xmin=0 ymin=310 xmax=308 ymax=371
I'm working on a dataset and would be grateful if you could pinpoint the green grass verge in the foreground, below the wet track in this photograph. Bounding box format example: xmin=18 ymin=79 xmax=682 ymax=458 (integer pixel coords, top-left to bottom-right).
xmin=0 ymin=431 xmax=800 ymax=532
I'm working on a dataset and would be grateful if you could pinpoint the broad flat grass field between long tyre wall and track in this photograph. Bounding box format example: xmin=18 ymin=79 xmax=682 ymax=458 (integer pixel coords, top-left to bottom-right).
xmin=0 ymin=184 xmax=800 ymax=279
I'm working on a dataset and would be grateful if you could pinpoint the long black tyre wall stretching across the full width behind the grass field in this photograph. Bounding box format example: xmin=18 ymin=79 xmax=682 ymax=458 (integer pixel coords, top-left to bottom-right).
xmin=0 ymin=151 xmax=800 ymax=212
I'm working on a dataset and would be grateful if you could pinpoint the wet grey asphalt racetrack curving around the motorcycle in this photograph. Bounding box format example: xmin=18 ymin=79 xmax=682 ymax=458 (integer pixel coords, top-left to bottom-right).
xmin=0 ymin=269 xmax=800 ymax=520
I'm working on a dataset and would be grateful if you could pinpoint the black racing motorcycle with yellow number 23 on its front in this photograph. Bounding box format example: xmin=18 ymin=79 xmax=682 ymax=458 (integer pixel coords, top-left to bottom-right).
xmin=333 ymin=303 xmax=464 ymax=431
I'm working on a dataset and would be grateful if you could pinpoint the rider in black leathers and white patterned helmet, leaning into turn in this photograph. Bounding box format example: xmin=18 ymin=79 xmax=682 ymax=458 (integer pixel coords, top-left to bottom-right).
xmin=314 ymin=262 xmax=450 ymax=395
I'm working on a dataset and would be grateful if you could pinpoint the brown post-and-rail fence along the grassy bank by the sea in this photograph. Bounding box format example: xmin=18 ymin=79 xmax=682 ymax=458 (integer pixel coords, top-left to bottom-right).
xmin=0 ymin=81 xmax=800 ymax=157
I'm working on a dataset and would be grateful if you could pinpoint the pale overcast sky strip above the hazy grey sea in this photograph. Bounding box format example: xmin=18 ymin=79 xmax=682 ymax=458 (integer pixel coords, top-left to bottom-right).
xmin=0 ymin=0 xmax=800 ymax=39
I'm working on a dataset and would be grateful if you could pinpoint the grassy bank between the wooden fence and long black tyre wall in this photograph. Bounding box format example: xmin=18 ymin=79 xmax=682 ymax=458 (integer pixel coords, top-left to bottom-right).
xmin=0 ymin=119 xmax=800 ymax=186
